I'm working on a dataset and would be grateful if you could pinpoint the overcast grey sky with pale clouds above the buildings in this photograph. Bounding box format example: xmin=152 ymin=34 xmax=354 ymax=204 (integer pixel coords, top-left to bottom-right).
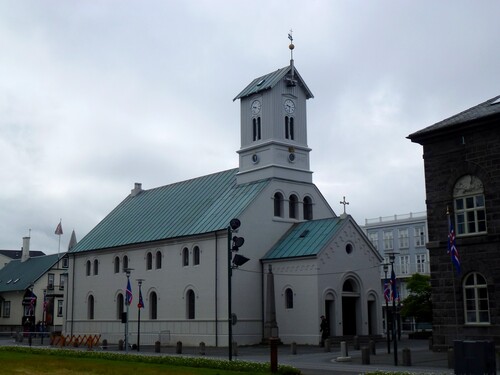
xmin=0 ymin=0 xmax=500 ymax=254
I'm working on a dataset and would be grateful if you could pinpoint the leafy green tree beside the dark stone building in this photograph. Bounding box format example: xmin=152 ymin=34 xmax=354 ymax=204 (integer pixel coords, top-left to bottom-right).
xmin=401 ymin=273 xmax=432 ymax=323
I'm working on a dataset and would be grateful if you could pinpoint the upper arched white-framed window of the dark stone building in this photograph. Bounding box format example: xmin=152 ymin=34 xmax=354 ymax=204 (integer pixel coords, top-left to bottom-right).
xmin=453 ymin=175 xmax=486 ymax=236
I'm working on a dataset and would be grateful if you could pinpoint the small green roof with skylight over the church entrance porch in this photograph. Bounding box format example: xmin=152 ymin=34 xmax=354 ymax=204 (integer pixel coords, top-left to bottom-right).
xmin=262 ymin=217 xmax=345 ymax=260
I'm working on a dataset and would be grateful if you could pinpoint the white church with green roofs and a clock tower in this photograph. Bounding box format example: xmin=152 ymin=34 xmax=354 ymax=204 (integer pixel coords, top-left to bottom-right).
xmin=63 ymin=46 xmax=383 ymax=346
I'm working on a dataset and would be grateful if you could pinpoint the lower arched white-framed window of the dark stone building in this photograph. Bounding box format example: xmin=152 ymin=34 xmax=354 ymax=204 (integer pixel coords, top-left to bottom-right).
xmin=464 ymin=272 xmax=490 ymax=324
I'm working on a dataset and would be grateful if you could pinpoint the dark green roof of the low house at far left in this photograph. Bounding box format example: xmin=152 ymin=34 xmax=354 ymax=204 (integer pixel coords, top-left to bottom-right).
xmin=0 ymin=254 xmax=59 ymax=293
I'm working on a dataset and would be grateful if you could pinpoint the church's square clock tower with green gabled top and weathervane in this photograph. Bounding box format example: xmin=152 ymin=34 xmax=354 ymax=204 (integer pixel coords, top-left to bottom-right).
xmin=234 ymin=34 xmax=313 ymax=184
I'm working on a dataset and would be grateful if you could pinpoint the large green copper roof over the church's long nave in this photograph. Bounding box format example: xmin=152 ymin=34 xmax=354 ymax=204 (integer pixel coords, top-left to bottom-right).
xmin=71 ymin=169 xmax=269 ymax=252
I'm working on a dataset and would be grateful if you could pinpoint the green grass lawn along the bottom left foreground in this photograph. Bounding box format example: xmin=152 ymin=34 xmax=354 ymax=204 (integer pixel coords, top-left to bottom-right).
xmin=0 ymin=347 xmax=300 ymax=375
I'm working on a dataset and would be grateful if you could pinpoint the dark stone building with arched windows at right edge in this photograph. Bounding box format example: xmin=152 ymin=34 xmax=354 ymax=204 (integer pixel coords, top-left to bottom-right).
xmin=408 ymin=96 xmax=500 ymax=346
